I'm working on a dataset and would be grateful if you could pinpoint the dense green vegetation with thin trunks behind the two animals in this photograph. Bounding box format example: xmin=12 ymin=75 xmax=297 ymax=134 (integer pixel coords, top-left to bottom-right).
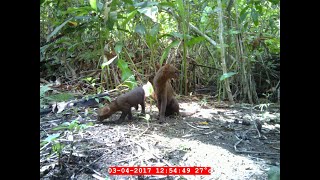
xmin=40 ymin=0 xmax=280 ymax=103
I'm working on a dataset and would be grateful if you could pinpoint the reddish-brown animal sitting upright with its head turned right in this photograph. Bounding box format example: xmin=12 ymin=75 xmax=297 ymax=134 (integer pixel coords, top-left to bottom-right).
xmin=153 ymin=64 xmax=179 ymax=122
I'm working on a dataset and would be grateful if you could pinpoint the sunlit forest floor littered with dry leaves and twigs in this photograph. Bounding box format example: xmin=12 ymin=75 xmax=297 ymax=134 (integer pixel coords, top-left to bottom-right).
xmin=40 ymin=96 xmax=280 ymax=180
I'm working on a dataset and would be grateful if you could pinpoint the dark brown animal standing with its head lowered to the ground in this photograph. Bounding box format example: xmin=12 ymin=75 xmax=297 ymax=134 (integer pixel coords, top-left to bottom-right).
xmin=98 ymin=87 xmax=145 ymax=121
